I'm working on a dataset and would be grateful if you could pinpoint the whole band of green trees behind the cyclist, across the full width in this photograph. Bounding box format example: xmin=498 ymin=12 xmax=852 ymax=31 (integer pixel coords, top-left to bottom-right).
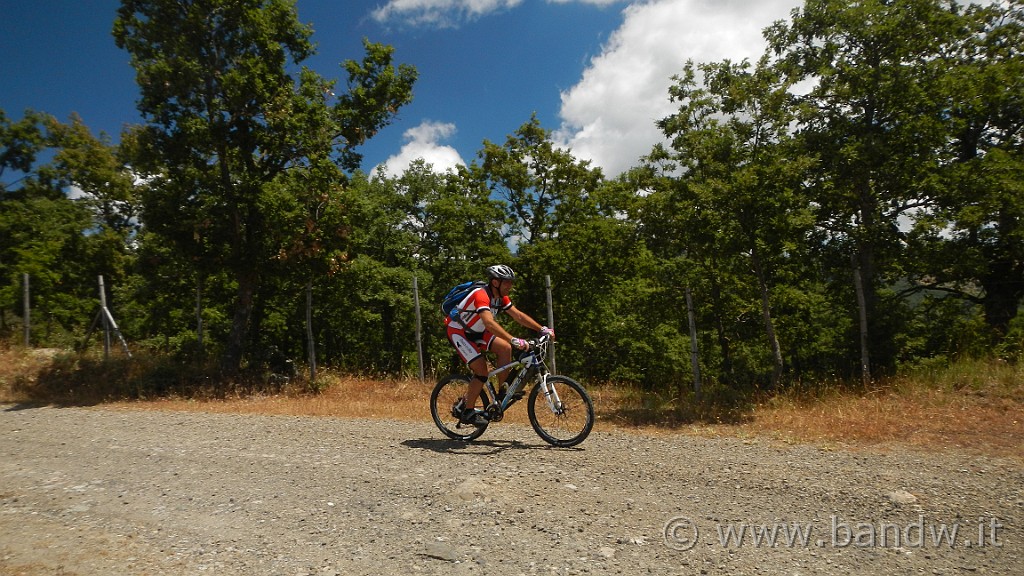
xmin=0 ymin=0 xmax=1024 ymax=396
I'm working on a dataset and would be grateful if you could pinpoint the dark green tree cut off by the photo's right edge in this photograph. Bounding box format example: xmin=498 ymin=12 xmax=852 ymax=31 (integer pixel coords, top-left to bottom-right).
xmin=911 ymin=0 xmax=1024 ymax=338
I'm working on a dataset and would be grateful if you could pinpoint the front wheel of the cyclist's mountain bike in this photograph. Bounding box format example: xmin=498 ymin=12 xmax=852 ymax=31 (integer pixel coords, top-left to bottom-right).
xmin=526 ymin=376 xmax=594 ymax=448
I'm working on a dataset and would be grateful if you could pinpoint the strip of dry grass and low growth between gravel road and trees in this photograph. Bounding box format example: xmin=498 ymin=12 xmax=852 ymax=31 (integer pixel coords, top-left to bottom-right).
xmin=0 ymin=343 xmax=1024 ymax=459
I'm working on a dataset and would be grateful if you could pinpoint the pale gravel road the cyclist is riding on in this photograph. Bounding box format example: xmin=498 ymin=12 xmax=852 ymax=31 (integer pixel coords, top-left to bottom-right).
xmin=0 ymin=405 xmax=1024 ymax=575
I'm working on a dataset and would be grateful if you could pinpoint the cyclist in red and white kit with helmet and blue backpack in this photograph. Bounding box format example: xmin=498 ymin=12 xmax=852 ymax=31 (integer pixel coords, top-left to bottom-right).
xmin=444 ymin=264 xmax=555 ymax=425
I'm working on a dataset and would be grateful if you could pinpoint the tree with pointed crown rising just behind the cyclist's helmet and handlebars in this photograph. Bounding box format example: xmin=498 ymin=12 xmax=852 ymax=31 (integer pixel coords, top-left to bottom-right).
xmin=471 ymin=115 xmax=606 ymax=374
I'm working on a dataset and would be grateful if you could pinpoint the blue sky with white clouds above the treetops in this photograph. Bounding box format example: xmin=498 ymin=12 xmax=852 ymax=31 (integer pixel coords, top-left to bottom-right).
xmin=0 ymin=0 xmax=801 ymax=176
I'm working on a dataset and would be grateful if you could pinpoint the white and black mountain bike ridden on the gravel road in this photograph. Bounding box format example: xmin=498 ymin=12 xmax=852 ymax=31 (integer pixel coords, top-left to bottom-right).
xmin=430 ymin=335 xmax=594 ymax=448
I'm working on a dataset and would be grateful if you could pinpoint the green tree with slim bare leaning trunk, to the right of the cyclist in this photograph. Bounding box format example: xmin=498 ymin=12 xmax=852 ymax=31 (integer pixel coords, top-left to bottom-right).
xmin=658 ymin=59 xmax=813 ymax=385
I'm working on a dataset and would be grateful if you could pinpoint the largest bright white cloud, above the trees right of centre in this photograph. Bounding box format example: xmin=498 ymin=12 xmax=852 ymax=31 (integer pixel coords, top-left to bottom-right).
xmin=554 ymin=0 xmax=803 ymax=176
